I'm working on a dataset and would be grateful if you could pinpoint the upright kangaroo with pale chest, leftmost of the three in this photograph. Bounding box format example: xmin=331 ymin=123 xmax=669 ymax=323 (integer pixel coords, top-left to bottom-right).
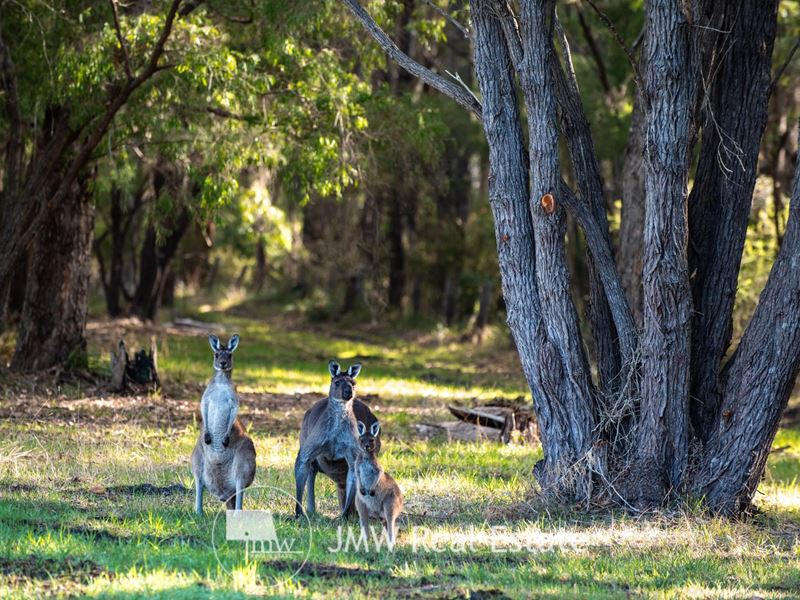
xmin=192 ymin=335 xmax=256 ymax=515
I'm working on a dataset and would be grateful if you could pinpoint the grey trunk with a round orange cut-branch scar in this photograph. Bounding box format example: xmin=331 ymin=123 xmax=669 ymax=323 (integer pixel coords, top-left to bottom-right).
xmin=518 ymin=0 xmax=595 ymax=497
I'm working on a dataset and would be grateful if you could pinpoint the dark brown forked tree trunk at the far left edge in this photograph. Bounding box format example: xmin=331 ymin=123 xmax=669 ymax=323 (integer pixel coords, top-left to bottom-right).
xmin=0 ymin=0 xmax=199 ymax=369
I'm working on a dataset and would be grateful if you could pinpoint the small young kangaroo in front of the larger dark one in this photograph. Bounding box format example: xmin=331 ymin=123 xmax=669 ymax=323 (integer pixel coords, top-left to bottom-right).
xmin=356 ymin=421 xmax=403 ymax=548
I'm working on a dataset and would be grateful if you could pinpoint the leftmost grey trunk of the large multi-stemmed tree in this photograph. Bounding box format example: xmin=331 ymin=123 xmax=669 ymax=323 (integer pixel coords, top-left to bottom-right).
xmin=470 ymin=0 xmax=594 ymax=497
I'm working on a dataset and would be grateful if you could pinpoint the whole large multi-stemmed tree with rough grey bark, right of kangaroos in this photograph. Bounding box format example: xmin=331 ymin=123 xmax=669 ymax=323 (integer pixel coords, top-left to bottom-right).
xmin=343 ymin=0 xmax=800 ymax=512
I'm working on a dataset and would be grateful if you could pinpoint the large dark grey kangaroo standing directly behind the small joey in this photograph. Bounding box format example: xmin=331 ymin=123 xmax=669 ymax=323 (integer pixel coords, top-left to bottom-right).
xmin=294 ymin=360 xmax=380 ymax=517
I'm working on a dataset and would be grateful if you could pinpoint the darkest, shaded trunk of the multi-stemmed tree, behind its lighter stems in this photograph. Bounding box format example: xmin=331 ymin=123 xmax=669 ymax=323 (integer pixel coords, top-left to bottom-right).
xmin=689 ymin=0 xmax=778 ymax=440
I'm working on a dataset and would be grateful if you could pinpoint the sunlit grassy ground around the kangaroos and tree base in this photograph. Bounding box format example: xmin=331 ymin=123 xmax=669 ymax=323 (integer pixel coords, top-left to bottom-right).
xmin=0 ymin=305 xmax=800 ymax=598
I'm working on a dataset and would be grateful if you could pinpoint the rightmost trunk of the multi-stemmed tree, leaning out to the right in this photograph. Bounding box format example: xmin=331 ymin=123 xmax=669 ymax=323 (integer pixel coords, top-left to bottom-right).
xmin=694 ymin=143 xmax=800 ymax=514
